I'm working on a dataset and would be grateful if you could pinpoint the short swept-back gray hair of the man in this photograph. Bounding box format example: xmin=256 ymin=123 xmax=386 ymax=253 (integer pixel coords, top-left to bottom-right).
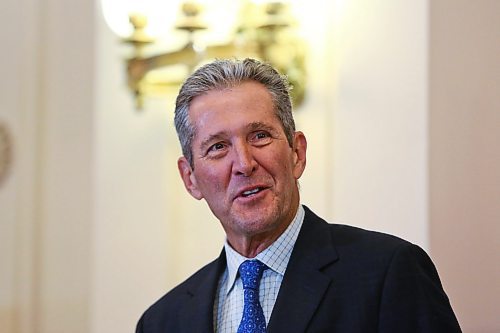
xmin=174 ymin=59 xmax=295 ymax=167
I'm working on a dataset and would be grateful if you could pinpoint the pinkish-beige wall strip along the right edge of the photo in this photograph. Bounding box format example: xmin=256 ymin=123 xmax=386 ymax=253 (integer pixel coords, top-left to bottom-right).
xmin=429 ymin=0 xmax=500 ymax=332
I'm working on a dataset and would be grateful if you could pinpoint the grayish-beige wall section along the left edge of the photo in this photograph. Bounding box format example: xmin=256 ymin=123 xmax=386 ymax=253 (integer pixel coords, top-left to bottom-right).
xmin=0 ymin=0 xmax=94 ymax=333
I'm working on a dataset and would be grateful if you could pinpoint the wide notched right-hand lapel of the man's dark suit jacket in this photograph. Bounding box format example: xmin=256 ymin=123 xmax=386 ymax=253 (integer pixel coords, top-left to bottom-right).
xmin=268 ymin=207 xmax=338 ymax=333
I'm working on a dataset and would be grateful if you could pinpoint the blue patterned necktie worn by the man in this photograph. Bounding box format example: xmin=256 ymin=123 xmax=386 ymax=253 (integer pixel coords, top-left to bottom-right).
xmin=238 ymin=260 xmax=267 ymax=333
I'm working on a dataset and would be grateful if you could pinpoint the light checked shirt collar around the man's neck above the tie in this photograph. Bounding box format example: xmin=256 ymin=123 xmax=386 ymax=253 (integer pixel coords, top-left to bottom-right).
xmin=224 ymin=205 xmax=304 ymax=293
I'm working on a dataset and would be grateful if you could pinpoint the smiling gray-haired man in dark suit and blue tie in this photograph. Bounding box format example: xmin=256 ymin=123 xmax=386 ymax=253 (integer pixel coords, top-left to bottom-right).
xmin=137 ymin=59 xmax=460 ymax=333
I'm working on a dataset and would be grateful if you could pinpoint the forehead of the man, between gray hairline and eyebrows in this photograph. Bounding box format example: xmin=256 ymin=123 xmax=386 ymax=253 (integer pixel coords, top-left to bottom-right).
xmin=189 ymin=81 xmax=281 ymax=137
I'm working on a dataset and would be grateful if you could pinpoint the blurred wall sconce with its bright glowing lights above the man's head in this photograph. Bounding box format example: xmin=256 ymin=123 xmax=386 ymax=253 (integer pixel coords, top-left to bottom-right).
xmin=101 ymin=0 xmax=306 ymax=110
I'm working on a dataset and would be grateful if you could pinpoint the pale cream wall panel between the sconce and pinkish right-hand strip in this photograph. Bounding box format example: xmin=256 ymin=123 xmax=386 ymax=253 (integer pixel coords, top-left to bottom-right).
xmin=330 ymin=0 xmax=428 ymax=244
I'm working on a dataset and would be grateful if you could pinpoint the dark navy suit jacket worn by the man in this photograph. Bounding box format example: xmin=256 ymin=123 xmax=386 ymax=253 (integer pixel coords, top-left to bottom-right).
xmin=136 ymin=207 xmax=460 ymax=333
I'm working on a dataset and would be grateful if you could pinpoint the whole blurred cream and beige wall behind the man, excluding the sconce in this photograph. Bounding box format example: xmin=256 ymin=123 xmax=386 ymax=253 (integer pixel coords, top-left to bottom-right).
xmin=0 ymin=0 xmax=500 ymax=333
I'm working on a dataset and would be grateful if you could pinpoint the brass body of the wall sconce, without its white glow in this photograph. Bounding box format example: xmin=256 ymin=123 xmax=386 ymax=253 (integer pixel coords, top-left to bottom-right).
xmin=124 ymin=1 xmax=306 ymax=110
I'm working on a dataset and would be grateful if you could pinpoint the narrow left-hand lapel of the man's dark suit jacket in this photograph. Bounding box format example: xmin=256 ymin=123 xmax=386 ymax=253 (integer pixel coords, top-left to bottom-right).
xmin=182 ymin=250 xmax=226 ymax=333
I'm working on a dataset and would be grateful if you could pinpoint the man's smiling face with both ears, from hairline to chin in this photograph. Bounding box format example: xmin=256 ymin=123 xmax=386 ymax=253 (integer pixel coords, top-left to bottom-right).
xmin=178 ymin=81 xmax=307 ymax=242
